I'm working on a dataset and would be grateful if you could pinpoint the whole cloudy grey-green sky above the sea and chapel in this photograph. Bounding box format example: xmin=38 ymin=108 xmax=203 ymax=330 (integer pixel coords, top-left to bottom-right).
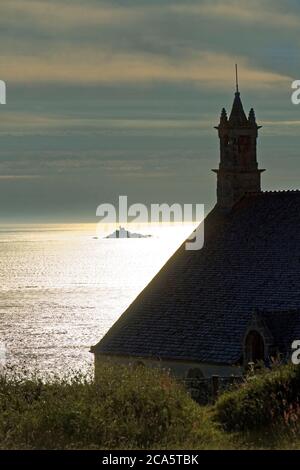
xmin=0 ymin=0 xmax=300 ymax=223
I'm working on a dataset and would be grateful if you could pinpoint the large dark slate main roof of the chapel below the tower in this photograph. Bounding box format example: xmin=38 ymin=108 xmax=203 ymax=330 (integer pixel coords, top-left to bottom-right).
xmin=92 ymin=191 xmax=300 ymax=364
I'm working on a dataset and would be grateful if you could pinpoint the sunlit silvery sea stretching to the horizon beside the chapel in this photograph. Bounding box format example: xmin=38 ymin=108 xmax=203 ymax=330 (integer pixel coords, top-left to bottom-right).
xmin=0 ymin=223 xmax=194 ymax=376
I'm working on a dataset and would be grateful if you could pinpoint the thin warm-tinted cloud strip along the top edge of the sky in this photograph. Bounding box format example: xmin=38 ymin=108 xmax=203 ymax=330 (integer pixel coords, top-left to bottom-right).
xmin=5 ymin=0 xmax=299 ymax=31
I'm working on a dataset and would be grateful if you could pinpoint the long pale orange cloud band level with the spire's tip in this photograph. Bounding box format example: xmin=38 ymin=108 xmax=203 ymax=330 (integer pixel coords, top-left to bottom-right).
xmin=0 ymin=47 xmax=292 ymax=87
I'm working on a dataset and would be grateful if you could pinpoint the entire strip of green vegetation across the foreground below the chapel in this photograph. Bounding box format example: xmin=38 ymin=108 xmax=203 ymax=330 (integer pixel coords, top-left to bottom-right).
xmin=0 ymin=366 xmax=300 ymax=449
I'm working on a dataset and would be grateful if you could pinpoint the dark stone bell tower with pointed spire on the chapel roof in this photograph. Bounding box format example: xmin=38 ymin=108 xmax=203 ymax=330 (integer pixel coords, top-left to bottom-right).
xmin=213 ymin=66 xmax=265 ymax=211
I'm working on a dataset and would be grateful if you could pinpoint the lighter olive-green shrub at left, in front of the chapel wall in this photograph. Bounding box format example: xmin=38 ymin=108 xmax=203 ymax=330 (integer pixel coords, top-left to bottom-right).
xmin=0 ymin=366 xmax=223 ymax=449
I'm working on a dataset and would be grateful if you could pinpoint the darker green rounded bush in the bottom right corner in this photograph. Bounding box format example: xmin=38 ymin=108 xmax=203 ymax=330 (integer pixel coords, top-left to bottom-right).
xmin=214 ymin=364 xmax=300 ymax=449
